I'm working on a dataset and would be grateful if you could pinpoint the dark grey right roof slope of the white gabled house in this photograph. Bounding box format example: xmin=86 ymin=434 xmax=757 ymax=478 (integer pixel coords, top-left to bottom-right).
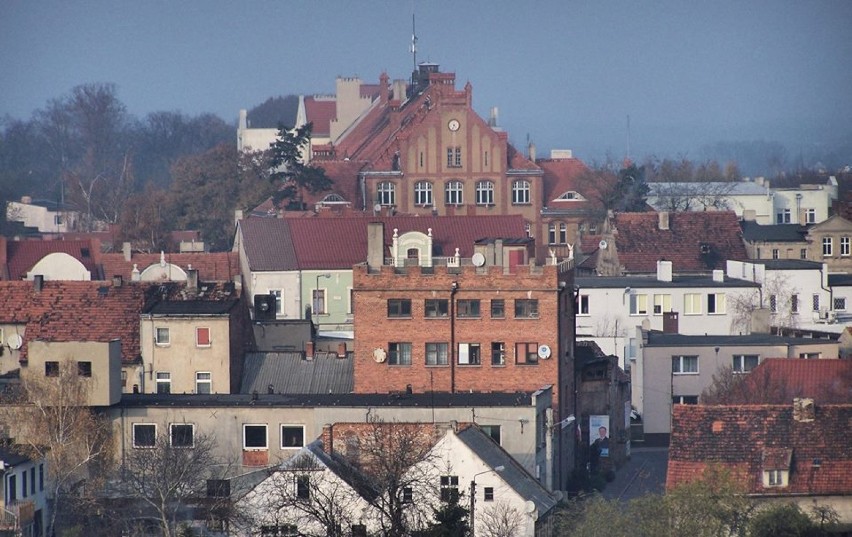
xmin=458 ymin=426 xmax=559 ymax=518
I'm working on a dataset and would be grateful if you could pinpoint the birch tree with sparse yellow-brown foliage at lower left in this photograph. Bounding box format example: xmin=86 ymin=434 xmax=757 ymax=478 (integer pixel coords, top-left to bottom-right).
xmin=0 ymin=359 xmax=113 ymax=535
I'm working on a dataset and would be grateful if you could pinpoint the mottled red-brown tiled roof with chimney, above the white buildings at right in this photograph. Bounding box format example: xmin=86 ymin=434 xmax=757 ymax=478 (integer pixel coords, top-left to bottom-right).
xmin=614 ymin=211 xmax=748 ymax=273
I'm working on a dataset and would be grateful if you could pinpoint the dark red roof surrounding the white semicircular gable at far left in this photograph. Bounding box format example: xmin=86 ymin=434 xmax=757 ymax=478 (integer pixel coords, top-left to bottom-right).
xmin=6 ymin=240 xmax=101 ymax=280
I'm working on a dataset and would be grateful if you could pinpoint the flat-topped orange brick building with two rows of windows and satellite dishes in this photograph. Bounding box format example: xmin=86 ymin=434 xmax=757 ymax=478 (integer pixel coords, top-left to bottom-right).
xmin=353 ymin=223 xmax=574 ymax=484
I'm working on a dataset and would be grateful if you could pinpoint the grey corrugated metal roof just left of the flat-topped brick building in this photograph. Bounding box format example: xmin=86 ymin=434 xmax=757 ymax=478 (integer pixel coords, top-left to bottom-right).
xmin=240 ymin=352 xmax=355 ymax=394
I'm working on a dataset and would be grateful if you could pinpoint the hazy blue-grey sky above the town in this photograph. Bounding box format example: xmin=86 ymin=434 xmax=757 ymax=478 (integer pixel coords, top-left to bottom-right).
xmin=0 ymin=0 xmax=852 ymax=162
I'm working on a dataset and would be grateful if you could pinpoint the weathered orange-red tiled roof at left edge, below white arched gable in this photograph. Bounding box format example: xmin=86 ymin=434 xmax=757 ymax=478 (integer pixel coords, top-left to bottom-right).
xmin=0 ymin=281 xmax=157 ymax=363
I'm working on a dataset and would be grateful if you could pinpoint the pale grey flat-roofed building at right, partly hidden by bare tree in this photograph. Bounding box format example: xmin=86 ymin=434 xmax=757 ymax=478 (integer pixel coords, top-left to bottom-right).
xmin=629 ymin=329 xmax=839 ymax=442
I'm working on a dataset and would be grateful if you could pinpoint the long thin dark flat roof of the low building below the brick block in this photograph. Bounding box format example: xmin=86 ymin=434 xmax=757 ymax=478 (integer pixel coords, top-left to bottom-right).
xmin=119 ymin=392 xmax=532 ymax=408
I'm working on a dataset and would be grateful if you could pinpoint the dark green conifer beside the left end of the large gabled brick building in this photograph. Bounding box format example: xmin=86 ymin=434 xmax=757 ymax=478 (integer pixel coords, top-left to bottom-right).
xmin=269 ymin=123 xmax=333 ymax=210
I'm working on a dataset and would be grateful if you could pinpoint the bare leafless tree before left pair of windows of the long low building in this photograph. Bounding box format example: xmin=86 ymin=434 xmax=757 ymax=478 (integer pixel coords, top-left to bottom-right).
xmin=120 ymin=430 xmax=226 ymax=537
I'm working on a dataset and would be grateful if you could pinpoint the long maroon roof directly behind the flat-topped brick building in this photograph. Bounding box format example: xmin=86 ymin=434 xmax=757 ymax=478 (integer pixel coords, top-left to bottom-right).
xmin=239 ymin=215 xmax=527 ymax=271
